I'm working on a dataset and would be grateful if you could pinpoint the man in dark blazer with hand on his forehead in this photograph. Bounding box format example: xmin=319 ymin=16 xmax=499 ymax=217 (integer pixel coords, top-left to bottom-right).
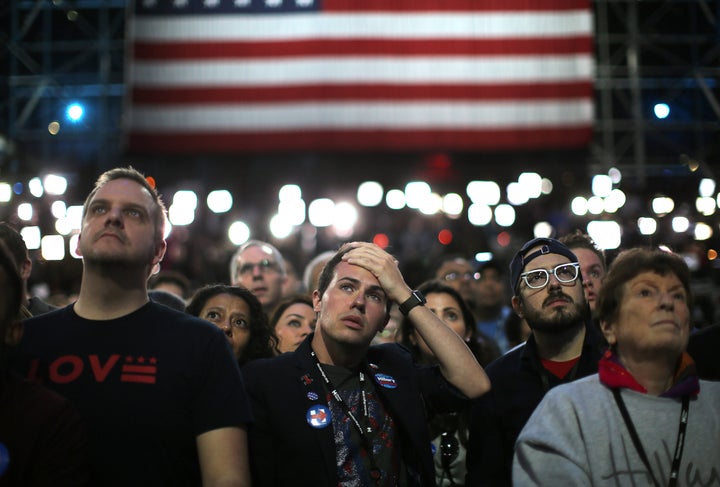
xmin=242 ymin=242 xmax=490 ymax=487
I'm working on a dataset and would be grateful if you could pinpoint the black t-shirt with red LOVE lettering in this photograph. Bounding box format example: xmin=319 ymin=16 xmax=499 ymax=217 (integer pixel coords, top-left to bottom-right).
xmin=13 ymin=302 xmax=251 ymax=487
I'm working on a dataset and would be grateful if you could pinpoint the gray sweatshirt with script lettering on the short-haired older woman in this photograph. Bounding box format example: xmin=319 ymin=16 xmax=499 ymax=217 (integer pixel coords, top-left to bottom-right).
xmin=513 ymin=374 xmax=720 ymax=487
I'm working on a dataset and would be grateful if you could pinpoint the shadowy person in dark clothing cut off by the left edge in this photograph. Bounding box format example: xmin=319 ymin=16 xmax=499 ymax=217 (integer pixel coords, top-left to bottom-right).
xmin=0 ymin=241 xmax=91 ymax=487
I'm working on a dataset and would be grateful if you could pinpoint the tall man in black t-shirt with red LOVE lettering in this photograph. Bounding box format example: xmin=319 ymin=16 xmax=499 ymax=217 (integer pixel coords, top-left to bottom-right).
xmin=12 ymin=168 xmax=251 ymax=487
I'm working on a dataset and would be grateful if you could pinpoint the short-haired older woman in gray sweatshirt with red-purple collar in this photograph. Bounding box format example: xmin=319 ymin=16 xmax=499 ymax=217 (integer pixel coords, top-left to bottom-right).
xmin=513 ymin=248 xmax=720 ymax=487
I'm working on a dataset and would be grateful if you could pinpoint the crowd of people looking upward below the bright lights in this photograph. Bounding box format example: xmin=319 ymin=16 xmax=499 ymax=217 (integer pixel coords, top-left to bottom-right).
xmin=0 ymin=167 xmax=720 ymax=487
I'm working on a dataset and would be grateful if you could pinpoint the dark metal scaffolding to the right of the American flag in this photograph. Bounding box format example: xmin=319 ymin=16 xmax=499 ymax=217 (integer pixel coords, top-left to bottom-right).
xmin=592 ymin=0 xmax=720 ymax=187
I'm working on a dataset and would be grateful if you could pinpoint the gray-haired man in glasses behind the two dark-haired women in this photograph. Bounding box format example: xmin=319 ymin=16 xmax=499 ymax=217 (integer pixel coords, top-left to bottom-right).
xmin=230 ymin=240 xmax=287 ymax=314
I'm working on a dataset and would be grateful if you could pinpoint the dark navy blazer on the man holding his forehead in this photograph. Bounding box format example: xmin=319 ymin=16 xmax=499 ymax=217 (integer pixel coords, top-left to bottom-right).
xmin=242 ymin=335 xmax=468 ymax=487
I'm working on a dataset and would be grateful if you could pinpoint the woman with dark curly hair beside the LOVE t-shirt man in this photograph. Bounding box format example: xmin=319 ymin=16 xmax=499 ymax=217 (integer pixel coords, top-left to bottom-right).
xmin=185 ymin=284 xmax=277 ymax=366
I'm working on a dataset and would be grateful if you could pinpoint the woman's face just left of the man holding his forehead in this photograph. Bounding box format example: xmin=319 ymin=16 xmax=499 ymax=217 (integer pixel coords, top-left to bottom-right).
xmin=270 ymin=294 xmax=316 ymax=354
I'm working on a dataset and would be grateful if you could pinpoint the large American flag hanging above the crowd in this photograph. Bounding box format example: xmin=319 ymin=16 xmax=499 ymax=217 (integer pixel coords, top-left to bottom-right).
xmin=125 ymin=0 xmax=594 ymax=153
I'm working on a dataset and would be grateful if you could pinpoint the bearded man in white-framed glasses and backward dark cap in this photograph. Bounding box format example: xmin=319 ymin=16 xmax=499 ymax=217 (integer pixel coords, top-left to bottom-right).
xmin=466 ymin=238 xmax=603 ymax=486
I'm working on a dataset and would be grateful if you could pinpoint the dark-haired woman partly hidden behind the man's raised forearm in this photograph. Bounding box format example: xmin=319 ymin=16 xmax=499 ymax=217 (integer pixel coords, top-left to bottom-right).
xmin=400 ymin=281 xmax=500 ymax=487
